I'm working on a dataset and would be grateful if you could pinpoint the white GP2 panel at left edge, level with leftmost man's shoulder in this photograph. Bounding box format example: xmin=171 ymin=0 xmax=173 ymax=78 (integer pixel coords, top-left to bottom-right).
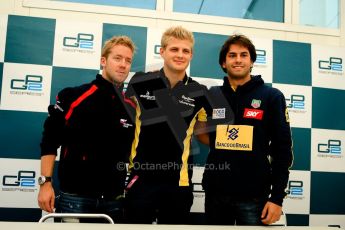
xmin=0 ymin=63 xmax=52 ymax=112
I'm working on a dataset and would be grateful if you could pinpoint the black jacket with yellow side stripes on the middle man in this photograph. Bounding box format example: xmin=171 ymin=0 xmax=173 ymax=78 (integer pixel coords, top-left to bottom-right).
xmin=126 ymin=69 xmax=211 ymax=186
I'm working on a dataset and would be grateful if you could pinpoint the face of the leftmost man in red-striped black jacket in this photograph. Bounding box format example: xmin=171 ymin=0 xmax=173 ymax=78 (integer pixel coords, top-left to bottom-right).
xmin=101 ymin=45 xmax=133 ymax=85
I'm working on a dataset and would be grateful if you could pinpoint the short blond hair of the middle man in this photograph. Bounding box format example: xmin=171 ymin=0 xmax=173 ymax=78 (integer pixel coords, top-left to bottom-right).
xmin=161 ymin=26 xmax=194 ymax=48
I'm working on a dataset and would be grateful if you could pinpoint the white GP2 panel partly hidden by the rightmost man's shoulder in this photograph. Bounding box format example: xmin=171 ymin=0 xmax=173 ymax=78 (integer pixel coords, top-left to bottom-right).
xmin=272 ymin=83 xmax=312 ymax=128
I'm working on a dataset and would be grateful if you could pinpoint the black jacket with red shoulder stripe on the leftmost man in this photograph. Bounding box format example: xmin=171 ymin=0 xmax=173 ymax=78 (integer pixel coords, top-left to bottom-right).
xmin=41 ymin=74 xmax=135 ymax=195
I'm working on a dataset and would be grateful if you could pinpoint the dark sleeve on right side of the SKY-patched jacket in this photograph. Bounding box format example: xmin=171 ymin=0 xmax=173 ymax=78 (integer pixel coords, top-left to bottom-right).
xmin=269 ymin=89 xmax=293 ymax=206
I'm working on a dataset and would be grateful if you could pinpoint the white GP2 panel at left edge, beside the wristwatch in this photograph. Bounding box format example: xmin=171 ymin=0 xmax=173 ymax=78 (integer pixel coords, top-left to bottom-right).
xmin=0 ymin=158 xmax=40 ymax=208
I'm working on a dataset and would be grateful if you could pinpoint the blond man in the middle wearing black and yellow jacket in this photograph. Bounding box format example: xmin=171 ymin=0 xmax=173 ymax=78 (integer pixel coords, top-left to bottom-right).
xmin=126 ymin=26 xmax=207 ymax=224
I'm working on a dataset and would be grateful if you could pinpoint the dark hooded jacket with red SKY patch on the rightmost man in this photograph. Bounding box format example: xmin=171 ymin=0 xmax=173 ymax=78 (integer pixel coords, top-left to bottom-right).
xmin=203 ymin=76 xmax=293 ymax=205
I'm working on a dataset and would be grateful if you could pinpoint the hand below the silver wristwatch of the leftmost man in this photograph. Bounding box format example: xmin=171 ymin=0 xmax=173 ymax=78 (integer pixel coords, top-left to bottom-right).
xmin=38 ymin=182 xmax=55 ymax=212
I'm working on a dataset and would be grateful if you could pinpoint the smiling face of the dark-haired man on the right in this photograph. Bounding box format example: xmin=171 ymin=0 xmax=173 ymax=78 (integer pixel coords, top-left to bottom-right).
xmin=222 ymin=44 xmax=253 ymax=79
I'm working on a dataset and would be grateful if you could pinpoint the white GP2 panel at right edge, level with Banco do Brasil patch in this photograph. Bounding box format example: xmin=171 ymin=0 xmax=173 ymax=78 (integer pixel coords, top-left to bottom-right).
xmin=311 ymin=129 xmax=345 ymax=172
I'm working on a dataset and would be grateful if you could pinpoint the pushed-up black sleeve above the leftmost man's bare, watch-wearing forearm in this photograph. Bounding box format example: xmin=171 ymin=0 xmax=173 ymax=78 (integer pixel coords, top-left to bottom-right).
xmin=40 ymin=88 xmax=70 ymax=156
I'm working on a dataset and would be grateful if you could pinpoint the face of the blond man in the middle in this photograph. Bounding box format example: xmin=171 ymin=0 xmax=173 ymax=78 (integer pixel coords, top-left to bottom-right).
xmin=160 ymin=38 xmax=193 ymax=72
